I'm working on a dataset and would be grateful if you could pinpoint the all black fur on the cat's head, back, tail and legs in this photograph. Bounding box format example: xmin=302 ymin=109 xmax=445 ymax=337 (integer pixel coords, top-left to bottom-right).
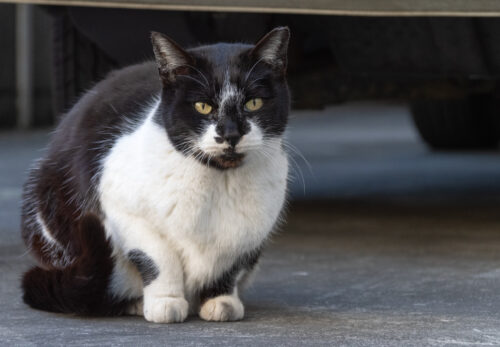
xmin=21 ymin=28 xmax=289 ymax=315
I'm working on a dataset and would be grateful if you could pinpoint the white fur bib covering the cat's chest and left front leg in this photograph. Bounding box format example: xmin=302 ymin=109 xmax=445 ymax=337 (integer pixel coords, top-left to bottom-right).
xmin=99 ymin=100 xmax=288 ymax=322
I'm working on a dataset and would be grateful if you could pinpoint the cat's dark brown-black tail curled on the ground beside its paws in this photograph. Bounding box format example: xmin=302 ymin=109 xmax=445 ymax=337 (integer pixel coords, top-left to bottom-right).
xmin=22 ymin=215 xmax=127 ymax=316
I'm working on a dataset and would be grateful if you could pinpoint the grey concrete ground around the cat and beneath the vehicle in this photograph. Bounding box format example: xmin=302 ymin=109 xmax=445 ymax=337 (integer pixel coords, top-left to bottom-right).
xmin=0 ymin=103 xmax=500 ymax=346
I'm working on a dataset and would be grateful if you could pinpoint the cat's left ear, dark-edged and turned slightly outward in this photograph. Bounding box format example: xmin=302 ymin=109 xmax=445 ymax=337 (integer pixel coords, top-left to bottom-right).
xmin=151 ymin=31 xmax=194 ymax=83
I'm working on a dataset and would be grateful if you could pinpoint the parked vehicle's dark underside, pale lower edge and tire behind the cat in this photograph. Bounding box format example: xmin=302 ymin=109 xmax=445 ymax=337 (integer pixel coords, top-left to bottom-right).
xmin=3 ymin=0 xmax=500 ymax=149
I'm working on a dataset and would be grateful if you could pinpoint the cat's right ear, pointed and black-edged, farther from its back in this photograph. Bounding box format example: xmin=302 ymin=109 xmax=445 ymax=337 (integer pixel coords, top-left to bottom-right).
xmin=250 ymin=27 xmax=290 ymax=72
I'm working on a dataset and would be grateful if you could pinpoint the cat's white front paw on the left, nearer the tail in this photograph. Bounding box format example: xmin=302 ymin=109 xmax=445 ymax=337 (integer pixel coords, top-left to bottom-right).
xmin=144 ymin=296 xmax=189 ymax=323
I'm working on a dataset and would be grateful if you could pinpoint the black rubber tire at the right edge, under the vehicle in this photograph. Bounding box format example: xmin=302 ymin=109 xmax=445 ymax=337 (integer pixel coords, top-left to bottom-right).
xmin=410 ymin=94 xmax=500 ymax=150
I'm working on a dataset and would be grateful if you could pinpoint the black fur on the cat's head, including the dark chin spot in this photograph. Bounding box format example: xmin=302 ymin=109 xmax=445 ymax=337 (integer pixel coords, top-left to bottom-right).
xmin=152 ymin=28 xmax=289 ymax=169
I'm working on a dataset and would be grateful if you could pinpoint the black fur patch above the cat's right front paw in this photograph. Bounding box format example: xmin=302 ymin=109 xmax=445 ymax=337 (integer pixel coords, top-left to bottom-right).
xmin=200 ymin=249 xmax=261 ymax=303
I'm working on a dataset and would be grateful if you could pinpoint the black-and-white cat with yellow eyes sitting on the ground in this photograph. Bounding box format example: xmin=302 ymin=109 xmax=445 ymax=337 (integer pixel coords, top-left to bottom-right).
xmin=21 ymin=27 xmax=290 ymax=323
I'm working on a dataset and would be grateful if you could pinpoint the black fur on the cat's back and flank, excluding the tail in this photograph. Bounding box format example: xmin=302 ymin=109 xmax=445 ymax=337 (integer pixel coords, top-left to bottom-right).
xmin=21 ymin=62 xmax=161 ymax=266
